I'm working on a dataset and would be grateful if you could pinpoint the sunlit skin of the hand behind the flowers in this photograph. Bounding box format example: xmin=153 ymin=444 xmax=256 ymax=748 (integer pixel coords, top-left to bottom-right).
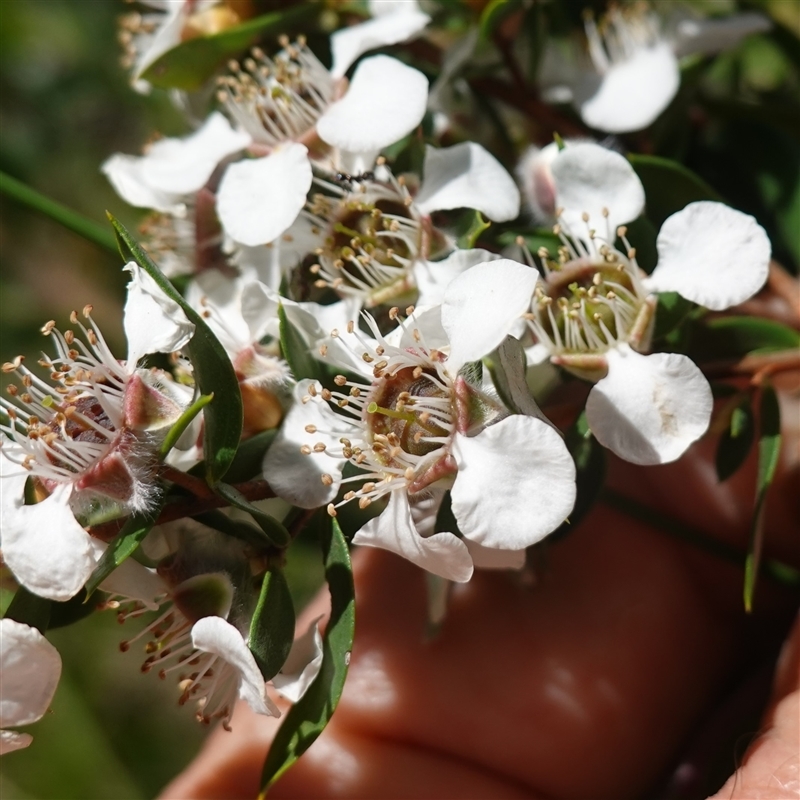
xmin=163 ymin=437 xmax=800 ymax=800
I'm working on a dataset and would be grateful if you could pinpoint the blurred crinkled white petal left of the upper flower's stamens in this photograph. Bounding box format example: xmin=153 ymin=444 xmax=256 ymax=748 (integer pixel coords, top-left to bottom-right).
xmin=100 ymin=111 xmax=250 ymax=217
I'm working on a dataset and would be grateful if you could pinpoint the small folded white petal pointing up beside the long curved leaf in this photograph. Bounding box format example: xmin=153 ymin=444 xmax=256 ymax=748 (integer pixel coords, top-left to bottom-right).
xmin=123 ymin=261 xmax=194 ymax=362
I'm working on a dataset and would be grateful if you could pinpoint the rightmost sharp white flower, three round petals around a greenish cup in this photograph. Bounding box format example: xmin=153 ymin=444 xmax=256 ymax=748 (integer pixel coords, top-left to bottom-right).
xmin=528 ymin=144 xmax=770 ymax=464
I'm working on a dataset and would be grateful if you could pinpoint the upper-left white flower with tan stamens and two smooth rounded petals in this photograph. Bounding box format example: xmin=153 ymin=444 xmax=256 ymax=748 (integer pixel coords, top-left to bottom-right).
xmin=218 ymin=40 xmax=428 ymax=246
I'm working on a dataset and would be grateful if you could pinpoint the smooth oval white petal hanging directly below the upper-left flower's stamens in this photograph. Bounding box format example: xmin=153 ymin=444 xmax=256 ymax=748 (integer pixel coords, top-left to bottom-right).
xmin=217 ymin=142 xmax=312 ymax=247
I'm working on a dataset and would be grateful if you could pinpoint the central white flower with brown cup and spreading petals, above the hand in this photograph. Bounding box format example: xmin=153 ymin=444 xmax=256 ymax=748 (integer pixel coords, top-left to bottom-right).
xmin=264 ymin=261 xmax=575 ymax=581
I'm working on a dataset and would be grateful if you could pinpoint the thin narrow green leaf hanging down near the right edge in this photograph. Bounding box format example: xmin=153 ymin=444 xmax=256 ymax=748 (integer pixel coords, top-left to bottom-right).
xmin=744 ymin=384 xmax=781 ymax=614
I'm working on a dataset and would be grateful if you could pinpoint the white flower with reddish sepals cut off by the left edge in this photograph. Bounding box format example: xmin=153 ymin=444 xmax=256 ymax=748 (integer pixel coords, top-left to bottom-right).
xmin=0 ymin=263 xmax=194 ymax=600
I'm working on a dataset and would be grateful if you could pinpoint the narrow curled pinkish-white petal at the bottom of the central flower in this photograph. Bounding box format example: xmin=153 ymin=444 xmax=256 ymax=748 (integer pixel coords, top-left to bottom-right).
xmin=353 ymin=490 xmax=472 ymax=583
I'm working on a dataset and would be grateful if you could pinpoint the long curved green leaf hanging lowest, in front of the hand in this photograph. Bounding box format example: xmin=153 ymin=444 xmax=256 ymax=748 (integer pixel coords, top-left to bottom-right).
xmin=259 ymin=519 xmax=355 ymax=798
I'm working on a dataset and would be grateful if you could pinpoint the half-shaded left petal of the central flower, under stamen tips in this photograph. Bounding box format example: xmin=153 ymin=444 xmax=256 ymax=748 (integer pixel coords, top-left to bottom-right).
xmin=263 ymin=380 xmax=352 ymax=508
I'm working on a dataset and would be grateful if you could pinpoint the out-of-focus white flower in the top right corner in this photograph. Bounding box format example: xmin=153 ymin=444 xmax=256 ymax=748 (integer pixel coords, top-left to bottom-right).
xmin=540 ymin=4 xmax=770 ymax=133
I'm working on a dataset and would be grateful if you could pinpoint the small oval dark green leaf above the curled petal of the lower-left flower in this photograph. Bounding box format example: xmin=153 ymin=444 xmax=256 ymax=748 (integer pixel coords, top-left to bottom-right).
xmin=248 ymin=567 xmax=295 ymax=681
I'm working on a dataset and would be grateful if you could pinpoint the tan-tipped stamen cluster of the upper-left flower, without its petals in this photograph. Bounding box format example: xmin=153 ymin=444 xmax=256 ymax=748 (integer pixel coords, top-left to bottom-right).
xmin=217 ymin=37 xmax=336 ymax=147
